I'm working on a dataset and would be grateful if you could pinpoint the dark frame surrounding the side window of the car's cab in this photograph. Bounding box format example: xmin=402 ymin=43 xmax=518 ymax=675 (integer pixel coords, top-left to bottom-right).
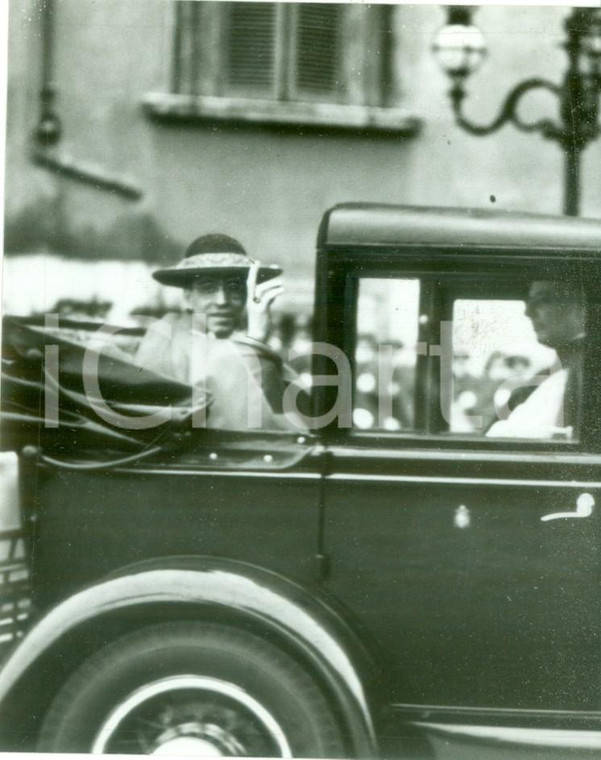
xmin=319 ymin=246 xmax=601 ymax=455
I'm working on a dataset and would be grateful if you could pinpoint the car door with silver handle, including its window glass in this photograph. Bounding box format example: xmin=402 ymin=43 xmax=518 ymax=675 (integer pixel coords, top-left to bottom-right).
xmin=324 ymin=267 xmax=601 ymax=716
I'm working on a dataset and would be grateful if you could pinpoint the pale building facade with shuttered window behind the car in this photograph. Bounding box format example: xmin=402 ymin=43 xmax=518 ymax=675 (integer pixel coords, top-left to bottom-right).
xmin=4 ymin=0 xmax=601 ymax=319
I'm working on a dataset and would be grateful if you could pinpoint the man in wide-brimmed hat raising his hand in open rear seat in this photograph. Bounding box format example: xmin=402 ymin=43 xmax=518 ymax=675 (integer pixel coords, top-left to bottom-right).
xmin=136 ymin=234 xmax=294 ymax=430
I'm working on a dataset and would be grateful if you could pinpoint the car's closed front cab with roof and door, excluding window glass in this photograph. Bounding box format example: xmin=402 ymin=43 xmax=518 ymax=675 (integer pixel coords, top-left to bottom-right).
xmin=315 ymin=204 xmax=601 ymax=746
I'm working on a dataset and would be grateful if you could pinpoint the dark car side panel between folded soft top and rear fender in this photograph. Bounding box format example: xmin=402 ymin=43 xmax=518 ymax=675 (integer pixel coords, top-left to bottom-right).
xmin=32 ymin=458 xmax=320 ymax=610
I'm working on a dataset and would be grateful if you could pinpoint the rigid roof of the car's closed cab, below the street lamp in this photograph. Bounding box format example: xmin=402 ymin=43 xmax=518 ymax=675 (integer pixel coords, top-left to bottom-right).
xmin=318 ymin=203 xmax=601 ymax=256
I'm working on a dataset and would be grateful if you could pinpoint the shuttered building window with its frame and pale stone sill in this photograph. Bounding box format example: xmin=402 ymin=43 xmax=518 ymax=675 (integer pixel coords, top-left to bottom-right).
xmin=145 ymin=0 xmax=419 ymax=134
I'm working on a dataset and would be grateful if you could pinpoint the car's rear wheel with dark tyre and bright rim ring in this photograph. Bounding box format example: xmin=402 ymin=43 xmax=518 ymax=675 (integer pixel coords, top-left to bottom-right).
xmin=38 ymin=622 xmax=345 ymax=757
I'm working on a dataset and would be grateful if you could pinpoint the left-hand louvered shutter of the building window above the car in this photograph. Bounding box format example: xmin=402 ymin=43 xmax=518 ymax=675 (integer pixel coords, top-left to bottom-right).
xmin=225 ymin=2 xmax=276 ymax=93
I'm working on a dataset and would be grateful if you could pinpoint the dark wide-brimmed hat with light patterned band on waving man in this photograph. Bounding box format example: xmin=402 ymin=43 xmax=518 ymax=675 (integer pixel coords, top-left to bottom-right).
xmin=152 ymin=233 xmax=282 ymax=288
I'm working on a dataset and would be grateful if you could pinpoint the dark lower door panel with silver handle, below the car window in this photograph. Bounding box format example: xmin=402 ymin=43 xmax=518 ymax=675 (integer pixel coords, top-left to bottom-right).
xmin=324 ymin=446 xmax=601 ymax=710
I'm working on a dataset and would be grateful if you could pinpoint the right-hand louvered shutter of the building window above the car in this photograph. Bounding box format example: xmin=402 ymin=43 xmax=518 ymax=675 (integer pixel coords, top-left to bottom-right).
xmin=295 ymin=3 xmax=342 ymax=99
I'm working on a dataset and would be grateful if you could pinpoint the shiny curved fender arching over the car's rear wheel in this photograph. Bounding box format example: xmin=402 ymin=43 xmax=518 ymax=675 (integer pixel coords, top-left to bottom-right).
xmin=0 ymin=557 xmax=376 ymax=756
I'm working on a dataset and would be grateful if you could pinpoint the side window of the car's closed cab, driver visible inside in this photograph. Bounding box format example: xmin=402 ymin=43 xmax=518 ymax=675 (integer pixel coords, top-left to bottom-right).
xmin=353 ymin=277 xmax=586 ymax=441
